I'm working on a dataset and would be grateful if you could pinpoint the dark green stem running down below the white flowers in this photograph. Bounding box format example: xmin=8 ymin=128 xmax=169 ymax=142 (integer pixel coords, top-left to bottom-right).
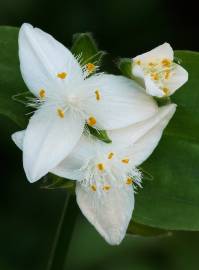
xmin=47 ymin=193 xmax=78 ymax=270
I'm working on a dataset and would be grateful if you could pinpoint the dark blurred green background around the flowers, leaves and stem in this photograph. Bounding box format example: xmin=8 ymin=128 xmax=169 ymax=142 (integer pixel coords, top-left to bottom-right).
xmin=0 ymin=0 xmax=199 ymax=270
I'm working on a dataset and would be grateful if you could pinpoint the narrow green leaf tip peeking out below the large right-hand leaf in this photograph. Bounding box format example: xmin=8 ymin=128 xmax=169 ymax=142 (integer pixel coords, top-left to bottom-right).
xmin=127 ymin=221 xmax=171 ymax=237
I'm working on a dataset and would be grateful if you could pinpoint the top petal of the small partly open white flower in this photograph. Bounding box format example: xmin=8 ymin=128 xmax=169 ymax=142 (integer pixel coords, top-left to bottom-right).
xmin=133 ymin=43 xmax=173 ymax=64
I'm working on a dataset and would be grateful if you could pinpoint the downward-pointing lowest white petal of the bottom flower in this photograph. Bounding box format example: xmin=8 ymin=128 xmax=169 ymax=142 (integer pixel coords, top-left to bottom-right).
xmin=76 ymin=183 xmax=134 ymax=245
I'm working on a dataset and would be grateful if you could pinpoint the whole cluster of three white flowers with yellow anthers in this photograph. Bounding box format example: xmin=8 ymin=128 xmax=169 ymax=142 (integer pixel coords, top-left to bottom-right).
xmin=12 ymin=24 xmax=188 ymax=245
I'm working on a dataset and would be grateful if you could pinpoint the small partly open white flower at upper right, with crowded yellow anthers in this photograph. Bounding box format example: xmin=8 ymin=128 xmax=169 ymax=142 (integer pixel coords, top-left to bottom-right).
xmin=132 ymin=43 xmax=188 ymax=98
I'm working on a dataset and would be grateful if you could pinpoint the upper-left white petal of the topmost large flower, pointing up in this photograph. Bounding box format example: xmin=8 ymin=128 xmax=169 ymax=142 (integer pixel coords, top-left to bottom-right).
xmin=19 ymin=23 xmax=83 ymax=96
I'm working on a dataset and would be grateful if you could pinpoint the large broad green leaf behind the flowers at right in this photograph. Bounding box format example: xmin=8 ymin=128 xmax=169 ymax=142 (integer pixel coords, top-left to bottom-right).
xmin=133 ymin=51 xmax=199 ymax=230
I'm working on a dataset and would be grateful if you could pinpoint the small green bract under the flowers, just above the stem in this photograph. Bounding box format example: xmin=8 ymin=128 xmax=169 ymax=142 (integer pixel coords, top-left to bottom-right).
xmin=41 ymin=173 xmax=75 ymax=190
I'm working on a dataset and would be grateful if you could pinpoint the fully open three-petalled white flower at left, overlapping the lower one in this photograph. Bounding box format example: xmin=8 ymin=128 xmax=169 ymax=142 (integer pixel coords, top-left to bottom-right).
xmin=16 ymin=24 xmax=157 ymax=182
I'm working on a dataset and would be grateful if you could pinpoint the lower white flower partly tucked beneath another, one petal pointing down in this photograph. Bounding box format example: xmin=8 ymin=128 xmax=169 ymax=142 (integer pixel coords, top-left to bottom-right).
xmin=12 ymin=104 xmax=176 ymax=245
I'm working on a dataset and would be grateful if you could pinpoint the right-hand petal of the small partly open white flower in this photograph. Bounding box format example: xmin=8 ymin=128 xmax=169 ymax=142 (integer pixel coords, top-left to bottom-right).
xmin=166 ymin=64 xmax=188 ymax=95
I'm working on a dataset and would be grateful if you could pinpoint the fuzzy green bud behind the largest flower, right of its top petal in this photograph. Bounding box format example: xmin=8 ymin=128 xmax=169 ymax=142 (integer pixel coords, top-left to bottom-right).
xmin=71 ymin=33 xmax=105 ymax=66
